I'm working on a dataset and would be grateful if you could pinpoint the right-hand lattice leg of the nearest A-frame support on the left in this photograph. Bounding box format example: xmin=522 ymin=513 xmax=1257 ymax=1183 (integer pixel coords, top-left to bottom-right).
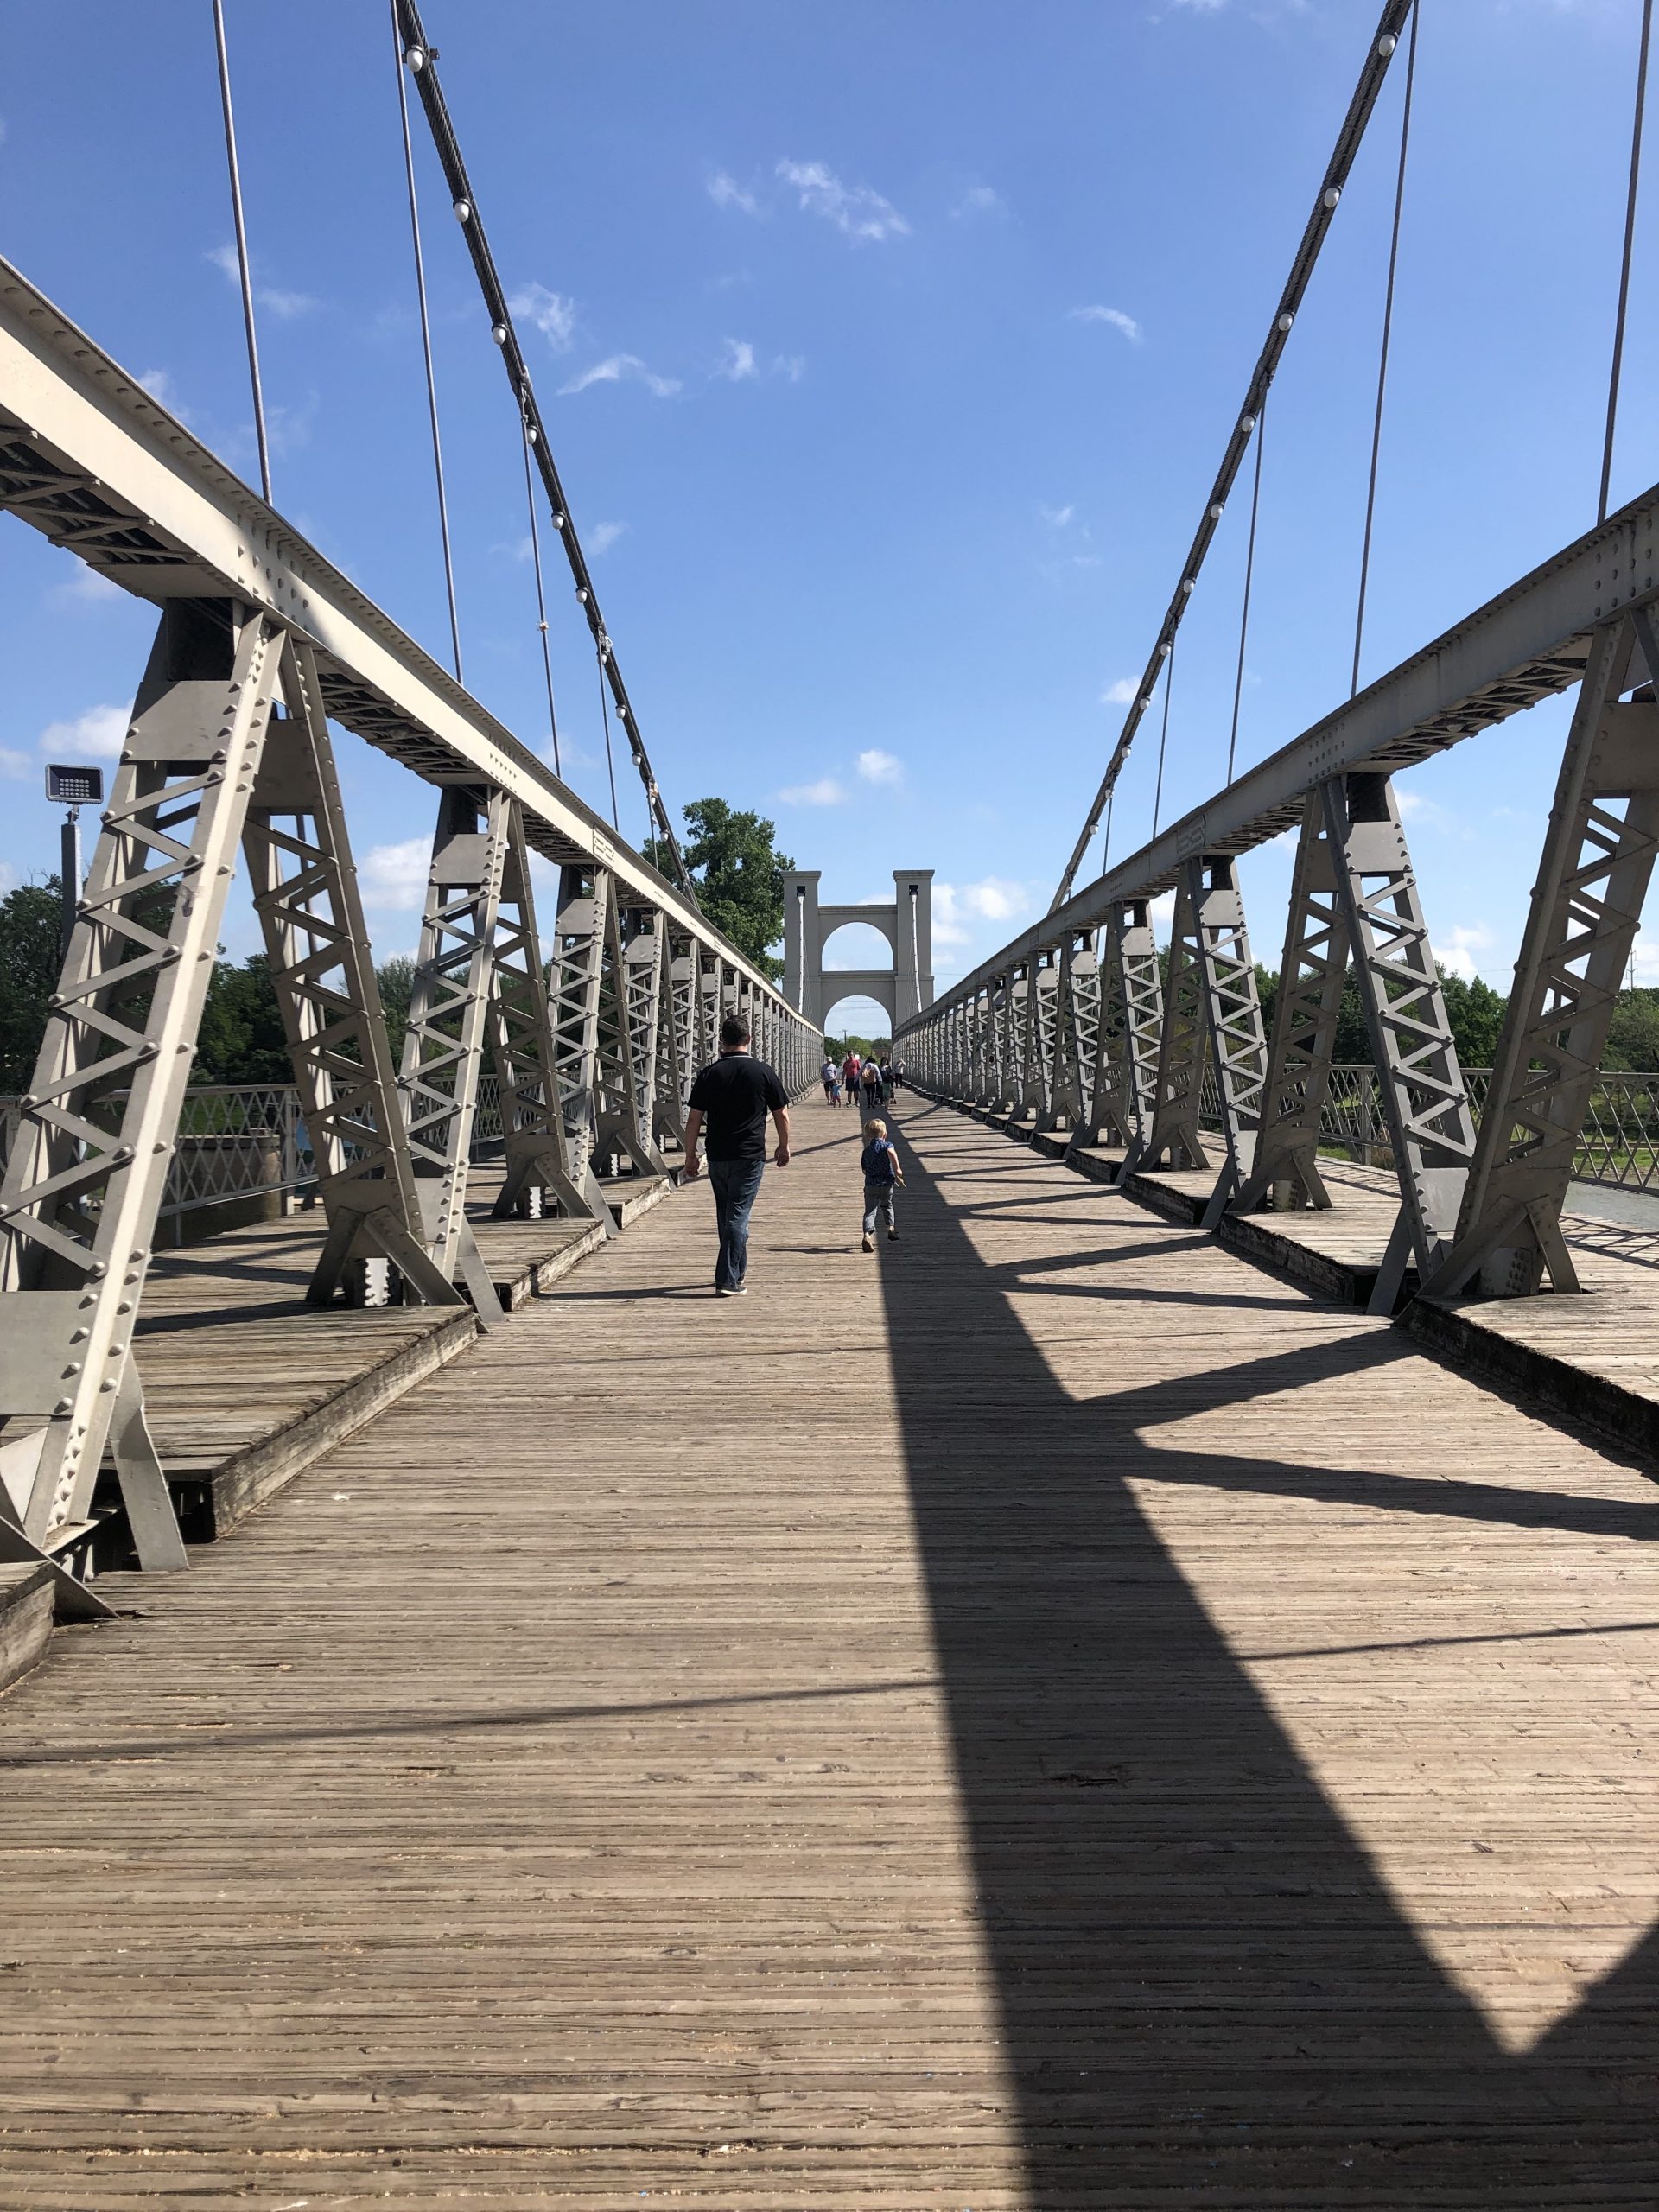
xmin=241 ymin=637 xmax=460 ymax=1305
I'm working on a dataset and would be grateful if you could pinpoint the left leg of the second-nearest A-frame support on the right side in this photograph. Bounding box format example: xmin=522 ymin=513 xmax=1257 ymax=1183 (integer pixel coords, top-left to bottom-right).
xmin=1232 ymin=791 xmax=1350 ymax=1212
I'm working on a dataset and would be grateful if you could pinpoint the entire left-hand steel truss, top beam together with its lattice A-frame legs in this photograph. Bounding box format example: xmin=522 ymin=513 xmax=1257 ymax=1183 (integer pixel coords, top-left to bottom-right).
xmin=0 ymin=264 xmax=818 ymax=1615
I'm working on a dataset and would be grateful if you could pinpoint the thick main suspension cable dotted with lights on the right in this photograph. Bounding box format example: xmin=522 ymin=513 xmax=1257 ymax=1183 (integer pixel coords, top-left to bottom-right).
xmin=1048 ymin=0 xmax=1411 ymax=913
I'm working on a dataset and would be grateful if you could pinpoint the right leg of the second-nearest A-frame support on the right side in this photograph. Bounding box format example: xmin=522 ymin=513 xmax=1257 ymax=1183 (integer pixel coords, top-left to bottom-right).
xmin=1323 ymin=774 xmax=1476 ymax=1314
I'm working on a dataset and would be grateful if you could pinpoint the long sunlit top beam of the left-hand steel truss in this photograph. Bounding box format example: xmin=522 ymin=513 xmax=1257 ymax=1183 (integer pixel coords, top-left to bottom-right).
xmin=0 ymin=261 xmax=805 ymax=1028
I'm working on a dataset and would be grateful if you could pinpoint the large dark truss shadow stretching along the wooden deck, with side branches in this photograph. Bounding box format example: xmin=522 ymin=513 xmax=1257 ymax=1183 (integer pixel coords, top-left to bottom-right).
xmin=882 ymin=1109 xmax=1659 ymax=2212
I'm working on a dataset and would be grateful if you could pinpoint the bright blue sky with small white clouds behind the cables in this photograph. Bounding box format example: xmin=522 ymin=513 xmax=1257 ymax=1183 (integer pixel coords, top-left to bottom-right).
xmin=0 ymin=0 xmax=1659 ymax=1039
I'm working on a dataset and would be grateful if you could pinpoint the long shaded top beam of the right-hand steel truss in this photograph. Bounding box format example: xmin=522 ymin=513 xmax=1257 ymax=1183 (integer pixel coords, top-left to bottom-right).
xmin=905 ymin=486 xmax=1659 ymax=1028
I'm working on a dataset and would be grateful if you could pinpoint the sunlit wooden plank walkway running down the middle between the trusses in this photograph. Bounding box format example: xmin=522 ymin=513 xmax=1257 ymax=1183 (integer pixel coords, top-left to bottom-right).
xmin=0 ymin=1102 xmax=1659 ymax=2212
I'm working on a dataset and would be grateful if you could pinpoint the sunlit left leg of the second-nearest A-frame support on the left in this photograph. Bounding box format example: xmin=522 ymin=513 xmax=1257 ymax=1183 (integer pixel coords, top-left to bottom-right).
xmin=398 ymin=783 xmax=511 ymax=1327
